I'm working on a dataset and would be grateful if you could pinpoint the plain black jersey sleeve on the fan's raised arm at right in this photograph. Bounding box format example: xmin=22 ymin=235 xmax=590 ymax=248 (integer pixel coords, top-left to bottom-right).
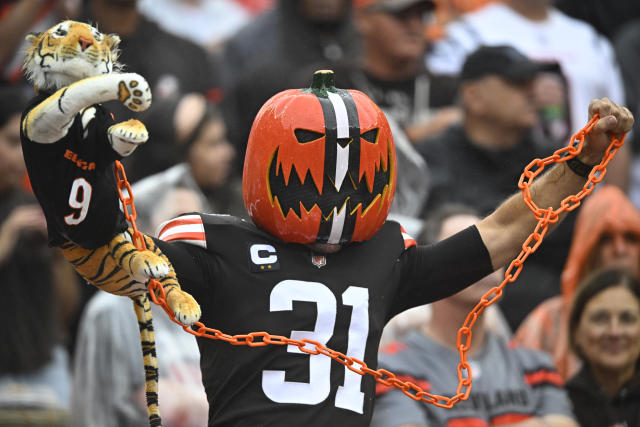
xmin=391 ymin=226 xmax=493 ymax=316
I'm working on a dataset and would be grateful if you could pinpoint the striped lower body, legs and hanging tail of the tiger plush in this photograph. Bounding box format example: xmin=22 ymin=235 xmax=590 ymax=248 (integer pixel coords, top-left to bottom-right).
xmin=61 ymin=230 xmax=200 ymax=427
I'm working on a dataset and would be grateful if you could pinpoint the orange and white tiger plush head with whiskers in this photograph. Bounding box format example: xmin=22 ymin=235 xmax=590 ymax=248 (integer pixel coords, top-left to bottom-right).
xmin=24 ymin=21 xmax=120 ymax=89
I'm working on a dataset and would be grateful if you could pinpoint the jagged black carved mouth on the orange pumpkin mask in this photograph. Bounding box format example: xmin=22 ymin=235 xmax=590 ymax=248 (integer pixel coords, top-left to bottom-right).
xmin=268 ymin=149 xmax=392 ymax=221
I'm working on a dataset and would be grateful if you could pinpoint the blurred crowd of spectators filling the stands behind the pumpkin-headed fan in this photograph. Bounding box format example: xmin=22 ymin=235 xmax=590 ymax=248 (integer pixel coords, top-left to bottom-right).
xmin=0 ymin=0 xmax=640 ymax=427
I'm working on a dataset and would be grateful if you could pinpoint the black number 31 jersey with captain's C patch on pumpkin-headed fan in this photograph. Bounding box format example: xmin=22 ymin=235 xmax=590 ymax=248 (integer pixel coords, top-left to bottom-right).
xmin=152 ymin=214 xmax=492 ymax=427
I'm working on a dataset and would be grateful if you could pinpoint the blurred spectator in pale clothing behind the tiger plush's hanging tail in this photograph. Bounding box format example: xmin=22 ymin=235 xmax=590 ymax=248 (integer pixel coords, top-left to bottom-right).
xmin=71 ymin=188 xmax=208 ymax=427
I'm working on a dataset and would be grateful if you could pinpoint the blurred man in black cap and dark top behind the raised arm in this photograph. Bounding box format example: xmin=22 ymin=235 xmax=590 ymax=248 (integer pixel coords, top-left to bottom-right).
xmin=417 ymin=46 xmax=574 ymax=330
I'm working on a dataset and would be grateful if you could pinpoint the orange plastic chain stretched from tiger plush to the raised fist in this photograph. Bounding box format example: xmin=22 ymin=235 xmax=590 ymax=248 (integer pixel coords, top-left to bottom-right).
xmin=115 ymin=115 xmax=625 ymax=408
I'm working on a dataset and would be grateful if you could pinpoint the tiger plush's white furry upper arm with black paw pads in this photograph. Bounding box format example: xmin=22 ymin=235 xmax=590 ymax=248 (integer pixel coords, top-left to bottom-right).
xmin=22 ymin=73 xmax=151 ymax=143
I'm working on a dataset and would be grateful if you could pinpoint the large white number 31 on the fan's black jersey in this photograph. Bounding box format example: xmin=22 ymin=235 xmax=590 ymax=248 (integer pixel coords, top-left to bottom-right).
xmin=262 ymin=280 xmax=369 ymax=414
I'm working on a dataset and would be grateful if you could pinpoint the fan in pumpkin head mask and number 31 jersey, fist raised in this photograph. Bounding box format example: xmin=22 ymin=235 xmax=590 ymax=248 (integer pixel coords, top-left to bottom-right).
xmin=46 ymin=65 xmax=633 ymax=427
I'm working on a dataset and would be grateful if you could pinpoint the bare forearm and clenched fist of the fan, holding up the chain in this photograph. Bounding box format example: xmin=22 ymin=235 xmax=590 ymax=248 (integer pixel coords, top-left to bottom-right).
xmin=477 ymin=98 xmax=633 ymax=269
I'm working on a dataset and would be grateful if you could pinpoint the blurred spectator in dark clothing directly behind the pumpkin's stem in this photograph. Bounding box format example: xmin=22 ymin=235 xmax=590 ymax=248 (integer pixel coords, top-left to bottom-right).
xmin=220 ymin=0 xmax=360 ymax=169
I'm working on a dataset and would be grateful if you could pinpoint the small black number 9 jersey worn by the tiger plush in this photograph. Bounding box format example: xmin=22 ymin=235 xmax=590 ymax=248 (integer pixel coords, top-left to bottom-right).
xmin=20 ymin=92 xmax=127 ymax=249
